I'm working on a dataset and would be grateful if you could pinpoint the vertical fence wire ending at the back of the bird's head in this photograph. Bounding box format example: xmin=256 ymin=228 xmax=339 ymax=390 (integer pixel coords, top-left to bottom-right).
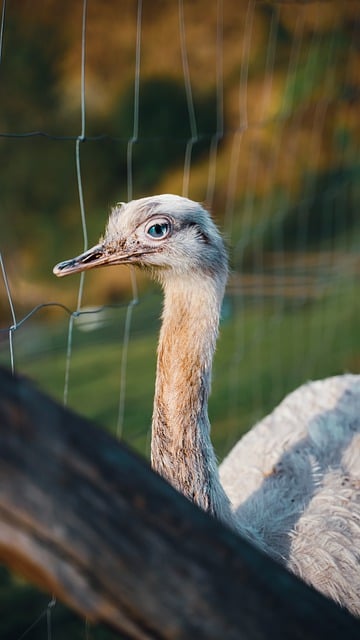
xmin=206 ymin=0 xmax=224 ymax=208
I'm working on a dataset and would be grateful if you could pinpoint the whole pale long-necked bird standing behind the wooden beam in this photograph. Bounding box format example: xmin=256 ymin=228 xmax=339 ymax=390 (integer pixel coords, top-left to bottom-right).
xmin=54 ymin=194 xmax=360 ymax=616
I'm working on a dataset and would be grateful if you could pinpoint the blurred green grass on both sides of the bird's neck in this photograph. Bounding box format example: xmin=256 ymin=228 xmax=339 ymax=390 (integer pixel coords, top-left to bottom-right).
xmin=0 ymin=281 xmax=360 ymax=458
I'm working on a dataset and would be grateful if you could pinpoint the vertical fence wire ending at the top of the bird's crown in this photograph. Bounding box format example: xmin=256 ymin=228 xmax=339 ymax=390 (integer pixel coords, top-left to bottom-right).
xmin=178 ymin=0 xmax=199 ymax=197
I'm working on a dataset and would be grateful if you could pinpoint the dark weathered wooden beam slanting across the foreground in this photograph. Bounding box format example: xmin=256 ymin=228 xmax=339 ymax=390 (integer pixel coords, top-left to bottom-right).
xmin=0 ymin=370 xmax=360 ymax=640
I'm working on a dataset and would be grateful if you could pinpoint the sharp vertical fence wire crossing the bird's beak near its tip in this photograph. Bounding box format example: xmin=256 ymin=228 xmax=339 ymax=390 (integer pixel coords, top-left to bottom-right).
xmin=63 ymin=0 xmax=88 ymax=405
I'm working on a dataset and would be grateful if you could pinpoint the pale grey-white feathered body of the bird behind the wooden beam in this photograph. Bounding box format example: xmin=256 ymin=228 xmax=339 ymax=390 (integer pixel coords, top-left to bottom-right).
xmin=220 ymin=375 xmax=360 ymax=615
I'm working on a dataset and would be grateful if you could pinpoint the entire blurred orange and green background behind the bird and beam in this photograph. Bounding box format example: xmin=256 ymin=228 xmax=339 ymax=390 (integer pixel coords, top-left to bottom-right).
xmin=0 ymin=0 xmax=360 ymax=640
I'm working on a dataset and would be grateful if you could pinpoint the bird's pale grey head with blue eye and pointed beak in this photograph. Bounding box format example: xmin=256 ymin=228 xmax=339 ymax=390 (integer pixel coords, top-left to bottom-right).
xmin=54 ymin=194 xmax=227 ymax=282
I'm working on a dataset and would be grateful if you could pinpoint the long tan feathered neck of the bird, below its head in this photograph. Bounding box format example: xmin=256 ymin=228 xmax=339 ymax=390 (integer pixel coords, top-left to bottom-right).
xmin=151 ymin=278 xmax=232 ymax=523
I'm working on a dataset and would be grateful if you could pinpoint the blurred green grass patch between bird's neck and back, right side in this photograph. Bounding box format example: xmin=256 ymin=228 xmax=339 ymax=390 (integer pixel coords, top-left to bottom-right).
xmin=210 ymin=287 xmax=360 ymax=457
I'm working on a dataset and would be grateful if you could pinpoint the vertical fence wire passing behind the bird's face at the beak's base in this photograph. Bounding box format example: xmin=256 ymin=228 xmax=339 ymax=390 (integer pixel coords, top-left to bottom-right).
xmin=115 ymin=0 xmax=142 ymax=438
